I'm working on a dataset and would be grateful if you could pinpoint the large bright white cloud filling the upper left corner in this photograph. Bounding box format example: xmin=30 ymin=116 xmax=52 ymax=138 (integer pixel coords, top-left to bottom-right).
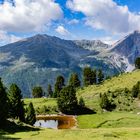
xmin=0 ymin=0 xmax=63 ymax=32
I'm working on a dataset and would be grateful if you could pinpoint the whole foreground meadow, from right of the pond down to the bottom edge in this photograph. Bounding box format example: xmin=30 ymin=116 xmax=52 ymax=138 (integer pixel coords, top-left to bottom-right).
xmin=0 ymin=112 xmax=140 ymax=140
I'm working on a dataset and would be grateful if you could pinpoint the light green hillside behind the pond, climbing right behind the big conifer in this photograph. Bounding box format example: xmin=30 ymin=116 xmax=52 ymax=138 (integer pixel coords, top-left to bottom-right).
xmin=24 ymin=70 xmax=140 ymax=114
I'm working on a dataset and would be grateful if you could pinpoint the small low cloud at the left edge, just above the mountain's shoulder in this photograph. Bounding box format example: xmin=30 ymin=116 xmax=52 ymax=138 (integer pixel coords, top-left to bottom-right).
xmin=0 ymin=30 xmax=21 ymax=46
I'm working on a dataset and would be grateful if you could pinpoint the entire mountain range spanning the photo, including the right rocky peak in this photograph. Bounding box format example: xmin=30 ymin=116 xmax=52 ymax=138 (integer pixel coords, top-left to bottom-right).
xmin=0 ymin=31 xmax=140 ymax=97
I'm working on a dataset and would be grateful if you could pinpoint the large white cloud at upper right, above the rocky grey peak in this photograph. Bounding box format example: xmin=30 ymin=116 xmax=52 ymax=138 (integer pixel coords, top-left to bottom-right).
xmin=67 ymin=0 xmax=140 ymax=33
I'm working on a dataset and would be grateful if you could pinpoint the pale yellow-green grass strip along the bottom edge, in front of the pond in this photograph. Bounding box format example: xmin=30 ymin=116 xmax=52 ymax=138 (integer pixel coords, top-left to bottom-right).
xmin=3 ymin=128 xmax=140 ymax=140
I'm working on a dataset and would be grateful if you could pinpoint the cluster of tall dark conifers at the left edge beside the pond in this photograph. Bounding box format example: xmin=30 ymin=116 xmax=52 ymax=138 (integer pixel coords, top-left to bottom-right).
xmin=0 ymin=78 xmax=36 ymax=127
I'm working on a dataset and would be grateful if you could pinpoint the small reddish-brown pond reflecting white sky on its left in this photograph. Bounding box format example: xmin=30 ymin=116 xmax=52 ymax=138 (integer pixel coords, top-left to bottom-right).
xmin=34 ymin=116 xmax=76 ymax=129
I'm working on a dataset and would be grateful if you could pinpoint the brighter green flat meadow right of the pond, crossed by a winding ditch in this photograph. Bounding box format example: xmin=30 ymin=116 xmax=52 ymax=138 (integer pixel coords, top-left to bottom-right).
xmin=77 ymin=112 xmax=140 ymax=129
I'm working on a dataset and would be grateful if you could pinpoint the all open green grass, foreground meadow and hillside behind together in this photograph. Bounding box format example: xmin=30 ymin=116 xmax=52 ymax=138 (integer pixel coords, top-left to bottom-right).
xmin=6 ymin=71 xmax=140 ymax=140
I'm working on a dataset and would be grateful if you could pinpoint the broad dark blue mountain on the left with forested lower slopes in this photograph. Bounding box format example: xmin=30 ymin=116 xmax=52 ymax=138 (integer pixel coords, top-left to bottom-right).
xmin=0 ymin=35 xmax=119 ymax=97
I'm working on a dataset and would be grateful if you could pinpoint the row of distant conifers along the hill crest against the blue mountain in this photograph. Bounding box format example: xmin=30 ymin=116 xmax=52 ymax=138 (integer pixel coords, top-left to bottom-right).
xmin=32 ymin=67 xmax=105 ymax=98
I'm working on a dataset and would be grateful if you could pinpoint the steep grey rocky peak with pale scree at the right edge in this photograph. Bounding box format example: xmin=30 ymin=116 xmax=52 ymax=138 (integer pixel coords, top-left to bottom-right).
xmin=110 ymin=31 xmax=140 ymax=71
